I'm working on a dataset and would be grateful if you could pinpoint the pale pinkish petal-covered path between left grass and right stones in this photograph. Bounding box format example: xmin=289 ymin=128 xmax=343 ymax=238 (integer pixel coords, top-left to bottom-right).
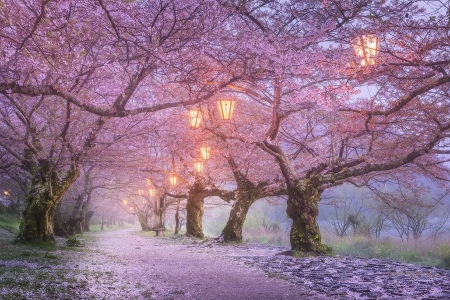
xmin=77 ymin=229 xmax=310 ymax=300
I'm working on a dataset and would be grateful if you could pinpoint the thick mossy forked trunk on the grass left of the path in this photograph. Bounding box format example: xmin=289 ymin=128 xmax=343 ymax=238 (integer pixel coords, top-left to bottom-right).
xmin=17 ymin=159 xmax=80 ymax=242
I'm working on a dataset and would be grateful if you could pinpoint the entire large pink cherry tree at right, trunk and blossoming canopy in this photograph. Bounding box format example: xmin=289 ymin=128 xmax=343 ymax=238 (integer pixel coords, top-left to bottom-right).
xmin=208 ymin=1 xmax=450 ymax=253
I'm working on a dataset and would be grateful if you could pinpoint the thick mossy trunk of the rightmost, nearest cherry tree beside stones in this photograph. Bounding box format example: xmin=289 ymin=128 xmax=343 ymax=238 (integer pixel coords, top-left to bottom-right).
xmin=286 ymin=179 xmax=331 ymax=254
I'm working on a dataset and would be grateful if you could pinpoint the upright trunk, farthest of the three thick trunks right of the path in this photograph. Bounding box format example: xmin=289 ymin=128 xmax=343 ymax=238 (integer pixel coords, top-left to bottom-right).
xmin=186 ymin=180 xmax=205 ymax=239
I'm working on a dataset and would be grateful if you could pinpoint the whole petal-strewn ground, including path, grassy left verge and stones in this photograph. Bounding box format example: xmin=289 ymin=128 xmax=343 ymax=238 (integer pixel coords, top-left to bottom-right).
xmin=0 ymin=228 xmax=450 ymax=300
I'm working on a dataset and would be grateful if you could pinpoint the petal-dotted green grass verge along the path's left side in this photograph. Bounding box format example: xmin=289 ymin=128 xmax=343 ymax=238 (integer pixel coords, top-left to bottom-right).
xmin=0 ymin=214 xmax=134 ymax=299
